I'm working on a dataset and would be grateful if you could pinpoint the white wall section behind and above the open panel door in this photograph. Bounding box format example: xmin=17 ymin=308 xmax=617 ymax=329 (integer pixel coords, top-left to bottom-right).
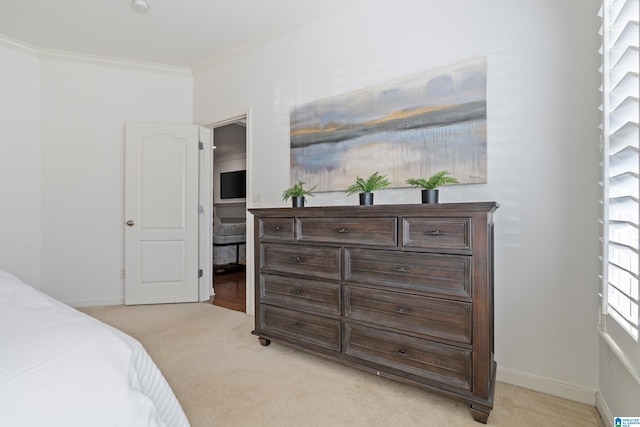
xmin=40 ymin=56 xmax=193 ymax=305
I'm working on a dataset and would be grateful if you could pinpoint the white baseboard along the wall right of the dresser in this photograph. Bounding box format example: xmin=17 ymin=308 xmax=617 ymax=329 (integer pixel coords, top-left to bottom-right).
xmin=496 ymin=367 xmax=597 ymax=406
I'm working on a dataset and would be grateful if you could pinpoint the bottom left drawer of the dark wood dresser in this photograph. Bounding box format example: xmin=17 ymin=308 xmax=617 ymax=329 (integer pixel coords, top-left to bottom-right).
xmin=257 ymin=305 xmax=340 ymax=351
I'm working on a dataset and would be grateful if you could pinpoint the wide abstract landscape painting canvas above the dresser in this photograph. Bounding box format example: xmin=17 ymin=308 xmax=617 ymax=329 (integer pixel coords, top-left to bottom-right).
xmin=291 ymin=58 xmax=487 ymax=191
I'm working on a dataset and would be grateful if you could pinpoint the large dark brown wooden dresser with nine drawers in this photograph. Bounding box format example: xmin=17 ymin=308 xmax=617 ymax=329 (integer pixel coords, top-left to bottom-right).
xmin=250 ymin=202 xmax=498 ymax=423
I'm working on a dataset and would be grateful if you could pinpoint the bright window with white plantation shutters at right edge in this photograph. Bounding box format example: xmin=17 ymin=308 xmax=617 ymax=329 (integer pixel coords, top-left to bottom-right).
xmin=600 ymin=0 xmax=640 ymax=382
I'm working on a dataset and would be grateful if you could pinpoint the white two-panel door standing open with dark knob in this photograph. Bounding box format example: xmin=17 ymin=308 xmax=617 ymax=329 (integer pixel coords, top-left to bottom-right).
xmin=124 ymin=123 xmax=199 ymax=305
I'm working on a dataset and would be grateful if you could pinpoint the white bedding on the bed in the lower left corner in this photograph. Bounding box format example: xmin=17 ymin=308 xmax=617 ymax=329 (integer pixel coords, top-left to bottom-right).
xmin=0 ymin=271 xmax=189 ymax=427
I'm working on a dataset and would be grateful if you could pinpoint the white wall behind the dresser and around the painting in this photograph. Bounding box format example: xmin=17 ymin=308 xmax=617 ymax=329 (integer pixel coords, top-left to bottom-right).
xmin=194 ymin=0 xmax=599 ymax=404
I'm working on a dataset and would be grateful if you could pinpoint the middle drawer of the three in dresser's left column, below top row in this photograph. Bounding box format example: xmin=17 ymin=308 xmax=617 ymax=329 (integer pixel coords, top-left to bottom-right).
xmin=260 ymin=274 xmax=340 ymax=316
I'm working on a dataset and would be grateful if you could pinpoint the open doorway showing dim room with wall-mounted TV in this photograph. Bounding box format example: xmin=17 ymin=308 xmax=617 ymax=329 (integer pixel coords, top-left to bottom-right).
xmin=211 ymin=117 xmax=248 ymax=313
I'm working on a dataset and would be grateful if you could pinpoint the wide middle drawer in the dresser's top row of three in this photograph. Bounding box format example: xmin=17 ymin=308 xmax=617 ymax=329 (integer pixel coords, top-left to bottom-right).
xmin=296 ymin=217 xmax=398 ymax=246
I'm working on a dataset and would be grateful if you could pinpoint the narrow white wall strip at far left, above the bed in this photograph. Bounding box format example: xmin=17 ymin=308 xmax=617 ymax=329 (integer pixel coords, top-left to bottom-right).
xmin=0 ymin=39 xmax=42 ymax=288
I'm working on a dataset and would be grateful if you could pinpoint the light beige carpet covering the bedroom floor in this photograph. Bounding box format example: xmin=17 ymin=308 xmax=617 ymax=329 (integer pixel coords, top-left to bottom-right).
xmin=81 ymin=303 xmax=603 ymax=427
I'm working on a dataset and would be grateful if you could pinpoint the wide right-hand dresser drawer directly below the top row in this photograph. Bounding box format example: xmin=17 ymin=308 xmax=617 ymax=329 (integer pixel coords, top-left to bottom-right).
xmin=345 ymin=248 xmax=471 ymax=300
